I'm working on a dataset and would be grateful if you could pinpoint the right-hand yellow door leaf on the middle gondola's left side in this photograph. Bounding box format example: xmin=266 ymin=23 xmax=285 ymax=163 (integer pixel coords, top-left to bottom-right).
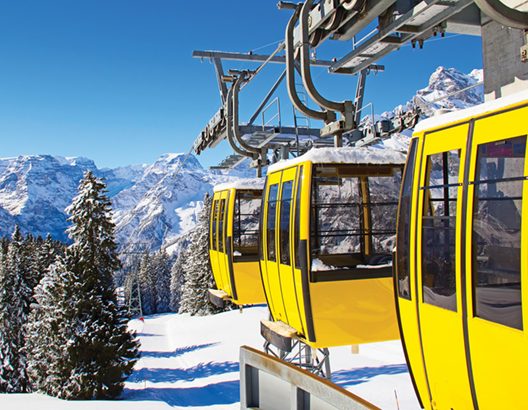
xmin=277 ymin=167 xmax=304 ymax=333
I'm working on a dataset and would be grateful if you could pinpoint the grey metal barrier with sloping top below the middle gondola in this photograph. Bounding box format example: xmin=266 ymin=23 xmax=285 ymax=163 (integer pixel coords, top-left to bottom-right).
xmin=240 ymin=346 xmax=379 ymax=410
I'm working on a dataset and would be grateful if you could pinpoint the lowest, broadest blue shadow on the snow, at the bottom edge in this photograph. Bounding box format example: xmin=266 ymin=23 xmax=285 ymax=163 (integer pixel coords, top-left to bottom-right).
xmin=123 ymin=380 xmax=240 ymax=407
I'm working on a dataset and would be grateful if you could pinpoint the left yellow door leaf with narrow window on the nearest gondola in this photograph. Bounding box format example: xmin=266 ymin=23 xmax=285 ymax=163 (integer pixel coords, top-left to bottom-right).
xmin=416 ymin=124 xmax=472 ymax=410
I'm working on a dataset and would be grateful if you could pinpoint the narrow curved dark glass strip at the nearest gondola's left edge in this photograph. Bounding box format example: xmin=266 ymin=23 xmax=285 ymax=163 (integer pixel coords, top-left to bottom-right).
xmin=396 ymin=139 xmax=418 ymax=299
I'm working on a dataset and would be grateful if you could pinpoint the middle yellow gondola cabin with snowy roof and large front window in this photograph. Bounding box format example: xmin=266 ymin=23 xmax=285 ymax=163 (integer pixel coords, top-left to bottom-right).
xmin=260 ymin=148 xmax=405 ymax=351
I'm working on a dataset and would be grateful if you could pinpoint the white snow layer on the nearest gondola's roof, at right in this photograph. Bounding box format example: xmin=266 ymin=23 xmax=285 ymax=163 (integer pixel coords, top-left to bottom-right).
xmin=414 ymin=90 xmax=528 ymax=133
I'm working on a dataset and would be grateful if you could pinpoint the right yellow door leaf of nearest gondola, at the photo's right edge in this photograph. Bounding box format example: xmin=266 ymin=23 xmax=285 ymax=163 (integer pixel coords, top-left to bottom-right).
xmin=465 ymin=107 xmax=528 ymax=409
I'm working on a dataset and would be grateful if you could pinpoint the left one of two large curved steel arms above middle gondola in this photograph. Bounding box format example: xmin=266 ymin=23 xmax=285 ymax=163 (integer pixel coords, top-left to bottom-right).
xmin=285 ymin=6 xmax=336 ymax=123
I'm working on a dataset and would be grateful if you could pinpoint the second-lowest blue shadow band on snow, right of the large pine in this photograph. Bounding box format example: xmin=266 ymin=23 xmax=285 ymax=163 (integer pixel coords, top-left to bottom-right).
xmin=128 ymin=362 xmax=239 ymax=383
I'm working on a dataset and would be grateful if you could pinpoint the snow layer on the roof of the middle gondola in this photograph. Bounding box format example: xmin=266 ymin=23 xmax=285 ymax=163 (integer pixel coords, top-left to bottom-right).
xmin=268 ymin=147 xmax=405 ymax=173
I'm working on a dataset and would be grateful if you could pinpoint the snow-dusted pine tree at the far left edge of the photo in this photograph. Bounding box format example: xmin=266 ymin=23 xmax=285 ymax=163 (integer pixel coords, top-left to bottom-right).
xmin=0 ymin=226 xmax=32 ymax=393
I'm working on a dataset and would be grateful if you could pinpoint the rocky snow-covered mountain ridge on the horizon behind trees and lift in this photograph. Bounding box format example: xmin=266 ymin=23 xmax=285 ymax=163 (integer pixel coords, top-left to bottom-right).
xmin=0 ymin=67 xmax=483 ymax=251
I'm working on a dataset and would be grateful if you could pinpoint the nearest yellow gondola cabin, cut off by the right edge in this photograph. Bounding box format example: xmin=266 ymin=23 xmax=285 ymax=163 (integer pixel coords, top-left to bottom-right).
xmin=395 ymin=91 xmax=528 ymax=410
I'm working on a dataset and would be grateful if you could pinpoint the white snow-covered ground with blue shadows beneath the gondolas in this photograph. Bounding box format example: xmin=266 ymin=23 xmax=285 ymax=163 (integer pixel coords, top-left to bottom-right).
xmin=0 ymin=306 xmax=419 ymax=410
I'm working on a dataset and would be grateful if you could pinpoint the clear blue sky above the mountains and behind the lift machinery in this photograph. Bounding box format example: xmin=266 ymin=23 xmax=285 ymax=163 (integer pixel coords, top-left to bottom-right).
xmin=0 ymin=0 xmax=482 ymax=167
